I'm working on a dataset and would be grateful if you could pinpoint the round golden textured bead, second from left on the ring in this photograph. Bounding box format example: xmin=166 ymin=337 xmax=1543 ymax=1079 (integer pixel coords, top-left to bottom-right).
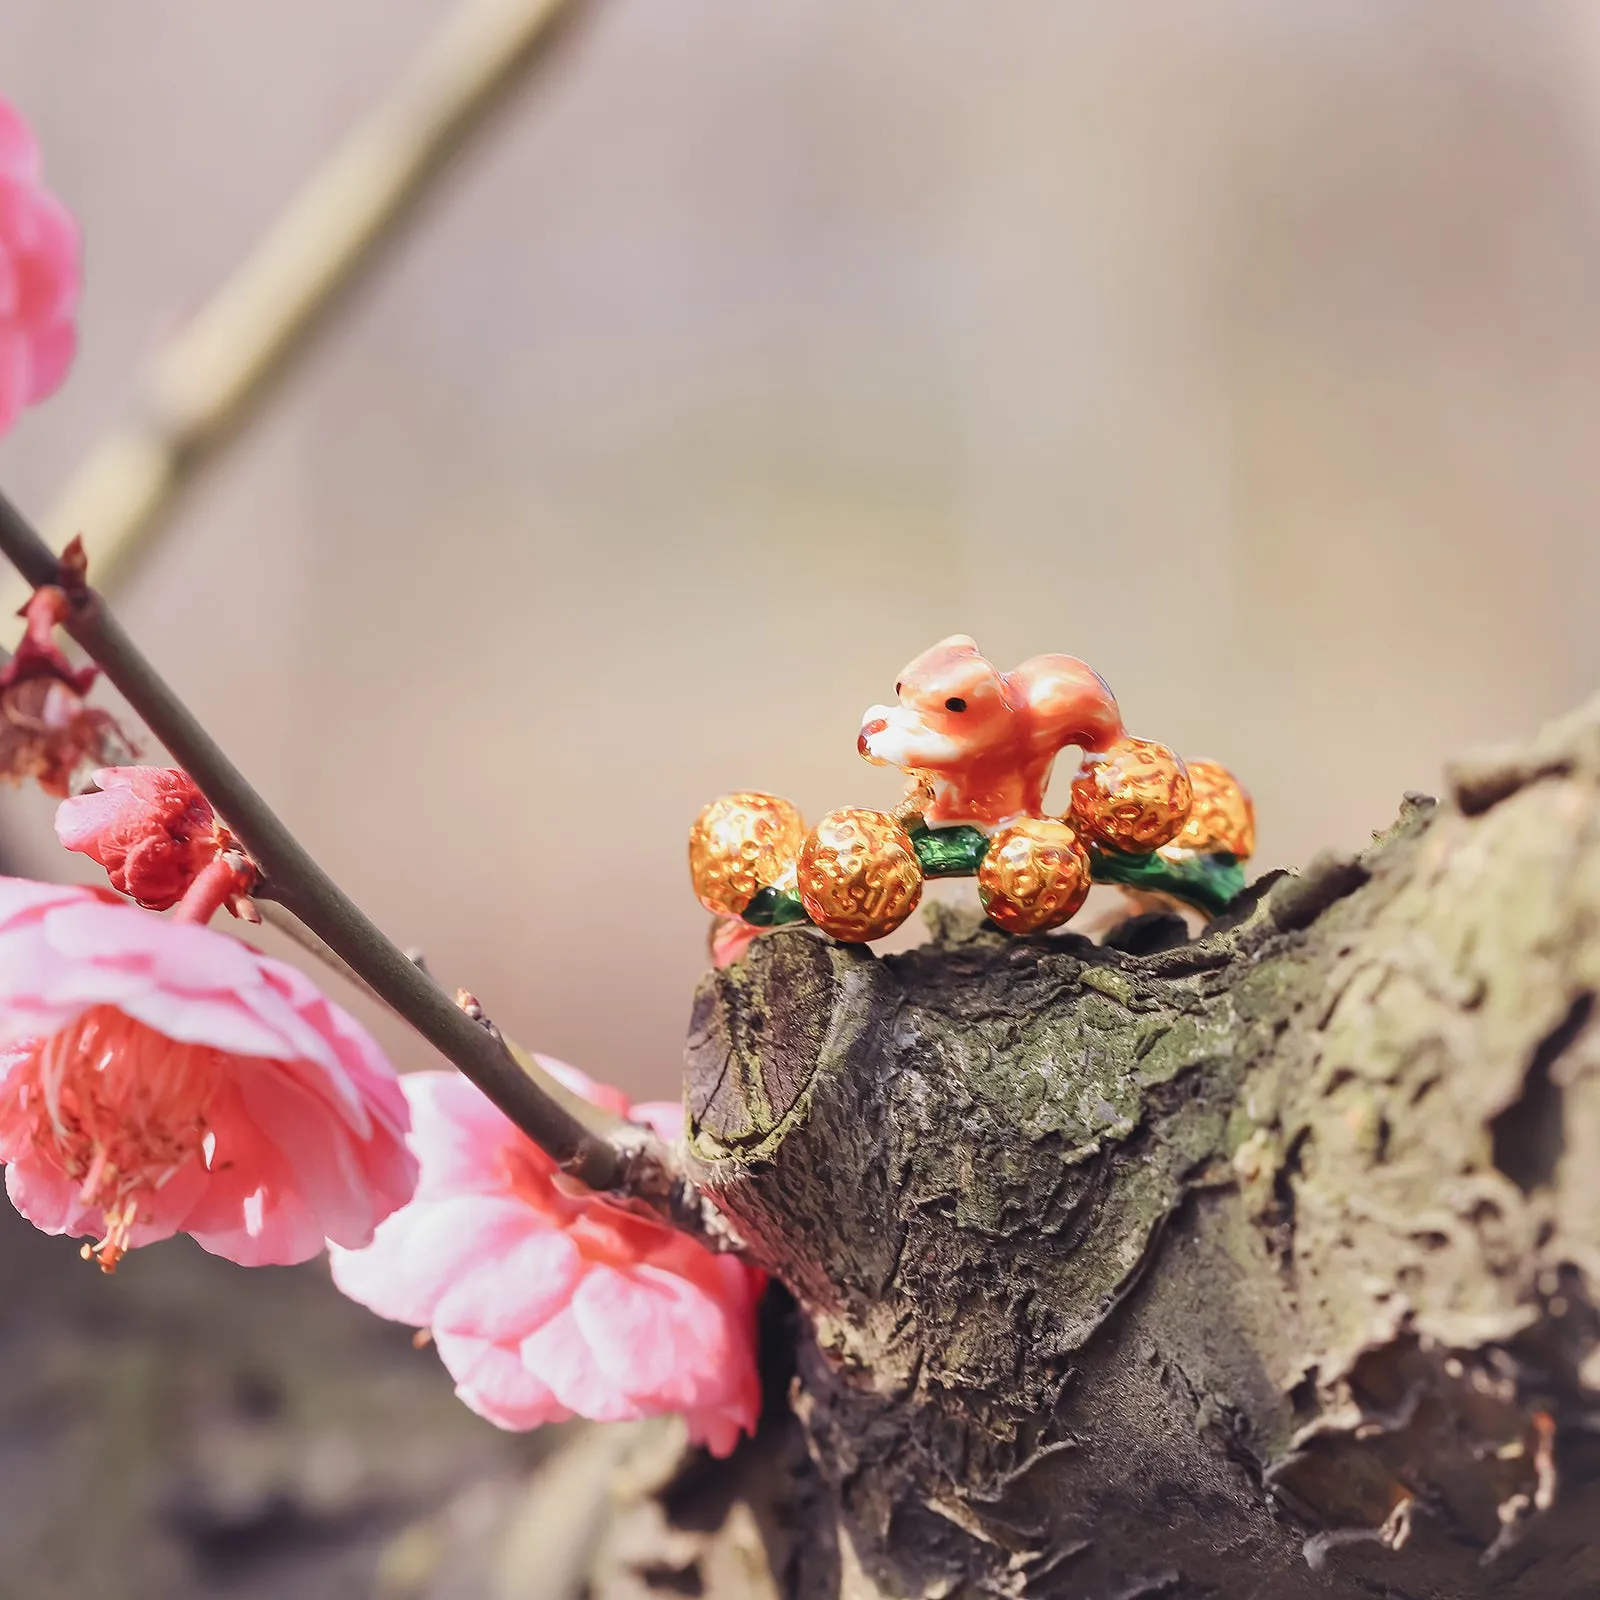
xmin=795 ymin=806 xmax=922 ymax=944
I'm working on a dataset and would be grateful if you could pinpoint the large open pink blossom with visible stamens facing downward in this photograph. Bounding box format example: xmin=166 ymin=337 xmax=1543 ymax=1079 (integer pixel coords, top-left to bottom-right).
xmin=0 ymin=877 xmax=416 ymax=1267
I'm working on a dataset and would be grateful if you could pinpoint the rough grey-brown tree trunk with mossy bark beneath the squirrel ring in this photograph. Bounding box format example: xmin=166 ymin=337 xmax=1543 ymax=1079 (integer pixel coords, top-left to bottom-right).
xmin=602 ymin=702 xmax=1600 ymax=1600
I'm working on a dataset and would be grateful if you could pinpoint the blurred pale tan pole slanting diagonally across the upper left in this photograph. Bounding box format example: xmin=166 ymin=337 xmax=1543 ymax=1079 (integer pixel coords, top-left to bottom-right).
xmin=0 ymin=0 xmax=582 ymax=616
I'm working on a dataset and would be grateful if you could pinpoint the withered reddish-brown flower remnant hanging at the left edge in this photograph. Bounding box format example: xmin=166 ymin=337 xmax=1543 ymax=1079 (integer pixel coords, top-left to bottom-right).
xmin=0 ymin=584 xmax=133 ymax=798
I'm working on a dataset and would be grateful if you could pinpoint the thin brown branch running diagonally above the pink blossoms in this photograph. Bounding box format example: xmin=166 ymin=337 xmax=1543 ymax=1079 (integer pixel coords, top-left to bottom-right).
xmin=0 ymin=480 xmax=634 ymax=1189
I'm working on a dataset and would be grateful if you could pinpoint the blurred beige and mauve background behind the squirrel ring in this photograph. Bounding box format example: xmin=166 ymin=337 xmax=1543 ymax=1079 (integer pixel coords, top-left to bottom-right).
xmin=0 ymin=0 xmax=1600 ymax=1093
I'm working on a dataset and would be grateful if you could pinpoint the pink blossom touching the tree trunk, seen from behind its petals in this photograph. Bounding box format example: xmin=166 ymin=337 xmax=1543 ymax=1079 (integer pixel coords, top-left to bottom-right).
xmin=333 ymin=1056 xmax=763 ymax=1456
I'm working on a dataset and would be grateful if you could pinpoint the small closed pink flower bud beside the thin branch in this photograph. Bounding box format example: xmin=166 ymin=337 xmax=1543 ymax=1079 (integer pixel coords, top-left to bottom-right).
xmin=56 ymin=766 xmax=232 ymax=910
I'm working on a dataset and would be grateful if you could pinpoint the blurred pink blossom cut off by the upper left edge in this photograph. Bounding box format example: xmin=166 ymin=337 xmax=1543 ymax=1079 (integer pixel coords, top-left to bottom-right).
xmin=0 ymin=99 xmax=78 ymax=435
